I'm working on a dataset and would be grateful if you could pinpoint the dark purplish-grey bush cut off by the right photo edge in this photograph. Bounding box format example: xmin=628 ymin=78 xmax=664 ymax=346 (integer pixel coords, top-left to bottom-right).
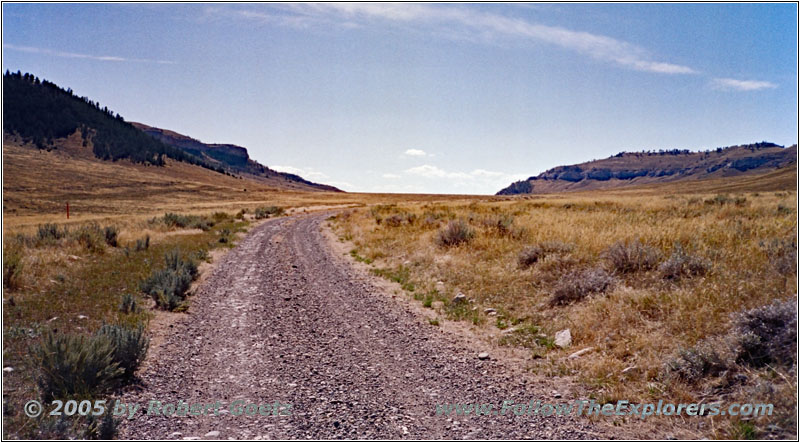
xmin=734 ymin=299 xmax=797 ymax=368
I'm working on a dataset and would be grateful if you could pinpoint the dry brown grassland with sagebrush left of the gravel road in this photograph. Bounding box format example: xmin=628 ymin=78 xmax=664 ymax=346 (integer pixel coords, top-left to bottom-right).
xmin=3 ymin=140 xmax=482 ymax=439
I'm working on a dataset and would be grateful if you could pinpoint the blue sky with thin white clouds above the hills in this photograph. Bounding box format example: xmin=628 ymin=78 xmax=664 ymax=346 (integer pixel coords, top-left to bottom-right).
xmin=2 ymin=3 xmax=798 ymax=194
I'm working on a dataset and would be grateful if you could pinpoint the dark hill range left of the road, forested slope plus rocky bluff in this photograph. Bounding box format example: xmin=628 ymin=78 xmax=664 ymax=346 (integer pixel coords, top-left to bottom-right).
xmin=3 ymin=71 xmax=341 ymax=192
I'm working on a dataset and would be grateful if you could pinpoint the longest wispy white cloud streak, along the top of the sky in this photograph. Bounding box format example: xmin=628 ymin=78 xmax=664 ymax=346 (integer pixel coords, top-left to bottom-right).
xmin=236 ymin=3 xmax=697 ymax=74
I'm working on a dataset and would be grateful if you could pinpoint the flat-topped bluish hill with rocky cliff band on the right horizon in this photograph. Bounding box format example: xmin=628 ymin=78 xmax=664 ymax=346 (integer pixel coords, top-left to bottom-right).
xmin=497 ymin=142 xmax=797 ymax=195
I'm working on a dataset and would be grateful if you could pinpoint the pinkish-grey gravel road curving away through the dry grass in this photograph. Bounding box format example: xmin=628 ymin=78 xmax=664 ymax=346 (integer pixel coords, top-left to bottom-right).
xmin=121 ymin=213 xmax=602 ymax=439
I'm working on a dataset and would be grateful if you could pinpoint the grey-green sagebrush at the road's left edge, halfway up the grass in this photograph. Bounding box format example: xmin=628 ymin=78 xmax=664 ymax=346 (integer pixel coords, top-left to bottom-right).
xmin=140 ymin=250 xmax=197 ymax=311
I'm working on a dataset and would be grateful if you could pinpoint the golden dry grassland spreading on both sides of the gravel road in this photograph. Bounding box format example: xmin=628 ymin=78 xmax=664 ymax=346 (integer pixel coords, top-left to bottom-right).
xmin=3 ymin=140 xmax=797 ymax=438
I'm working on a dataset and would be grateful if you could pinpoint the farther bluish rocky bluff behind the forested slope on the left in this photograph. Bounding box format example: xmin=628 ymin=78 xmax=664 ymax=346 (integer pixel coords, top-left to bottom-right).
xmin=131 ymin=122 xmax=342 ymax=192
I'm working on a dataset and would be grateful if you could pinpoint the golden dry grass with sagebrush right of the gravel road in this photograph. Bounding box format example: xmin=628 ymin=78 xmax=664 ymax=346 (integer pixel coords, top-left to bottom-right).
xmin=332 ymin=187 xmax=797 ymax=438
